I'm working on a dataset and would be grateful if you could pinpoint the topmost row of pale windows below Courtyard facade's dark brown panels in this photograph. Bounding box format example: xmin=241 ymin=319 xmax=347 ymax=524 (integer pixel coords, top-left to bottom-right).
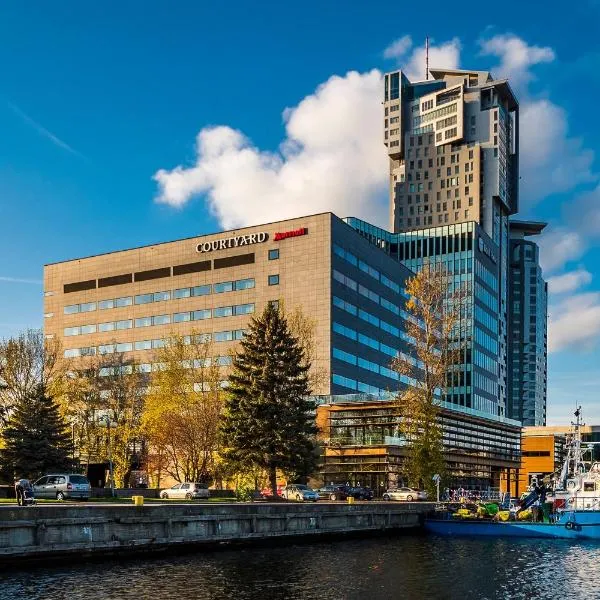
xmin=64 ymin=277 xmax=258 ymax=315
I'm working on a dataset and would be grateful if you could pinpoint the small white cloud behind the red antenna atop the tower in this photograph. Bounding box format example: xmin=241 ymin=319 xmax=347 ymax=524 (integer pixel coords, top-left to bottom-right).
xmin=383 ymin=35 xmax=461 ymax=81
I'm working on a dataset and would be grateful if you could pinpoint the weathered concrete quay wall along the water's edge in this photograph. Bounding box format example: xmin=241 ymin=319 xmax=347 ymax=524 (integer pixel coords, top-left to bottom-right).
xmin=0 ymin=503 xmax=429 ymax=566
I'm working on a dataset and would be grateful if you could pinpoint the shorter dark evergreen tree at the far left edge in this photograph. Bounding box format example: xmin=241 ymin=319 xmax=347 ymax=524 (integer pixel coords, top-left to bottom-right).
xmin=0 ymin=386 xmax=72 ymax=479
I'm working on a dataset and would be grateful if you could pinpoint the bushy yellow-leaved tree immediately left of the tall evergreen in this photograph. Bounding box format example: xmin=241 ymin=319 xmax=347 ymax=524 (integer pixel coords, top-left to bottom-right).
xmin=142 ymin=333 xmax=223 ymax=486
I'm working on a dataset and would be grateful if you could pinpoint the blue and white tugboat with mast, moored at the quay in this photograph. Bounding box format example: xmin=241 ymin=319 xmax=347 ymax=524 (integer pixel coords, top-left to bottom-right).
xmin=425 ymin=407 xmax=600 ymax=540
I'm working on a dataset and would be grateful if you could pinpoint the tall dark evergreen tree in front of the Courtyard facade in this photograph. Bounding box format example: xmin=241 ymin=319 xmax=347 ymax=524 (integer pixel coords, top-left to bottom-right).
xmin=221 ymin=304 xmax=316 ymax=495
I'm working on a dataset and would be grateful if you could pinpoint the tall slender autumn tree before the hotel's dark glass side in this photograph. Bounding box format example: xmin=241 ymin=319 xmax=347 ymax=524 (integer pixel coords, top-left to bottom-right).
xmin=392 ymin=265 xmax=465 ymax=493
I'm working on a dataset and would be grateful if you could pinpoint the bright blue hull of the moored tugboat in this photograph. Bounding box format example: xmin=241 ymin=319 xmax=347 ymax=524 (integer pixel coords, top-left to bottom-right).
xmin=425 ymin=511 xmax=600 ymax=540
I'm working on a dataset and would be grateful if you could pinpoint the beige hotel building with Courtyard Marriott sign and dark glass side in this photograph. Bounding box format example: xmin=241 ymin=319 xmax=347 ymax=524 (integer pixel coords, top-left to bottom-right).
xmin=44 ymin=213 xmax=422 ymax=394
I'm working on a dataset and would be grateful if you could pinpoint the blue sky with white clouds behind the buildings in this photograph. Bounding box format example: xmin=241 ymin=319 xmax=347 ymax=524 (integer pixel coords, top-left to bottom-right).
xmin=0 ymin=0 xmax=600 ymax=422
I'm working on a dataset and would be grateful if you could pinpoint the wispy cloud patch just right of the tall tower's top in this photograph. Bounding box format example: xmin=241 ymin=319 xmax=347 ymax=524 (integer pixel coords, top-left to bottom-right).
xmin=480 ymin=34 xmax=596 ymax=209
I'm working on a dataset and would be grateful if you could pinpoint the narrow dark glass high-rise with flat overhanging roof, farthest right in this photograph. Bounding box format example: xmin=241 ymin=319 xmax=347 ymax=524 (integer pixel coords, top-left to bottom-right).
xmin=507 ymin=221 xmax=548 ymax=426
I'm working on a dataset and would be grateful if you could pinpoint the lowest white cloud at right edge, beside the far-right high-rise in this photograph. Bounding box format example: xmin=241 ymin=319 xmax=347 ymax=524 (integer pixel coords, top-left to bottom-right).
xmin=548 ymin=292 xmax=600 ymax=352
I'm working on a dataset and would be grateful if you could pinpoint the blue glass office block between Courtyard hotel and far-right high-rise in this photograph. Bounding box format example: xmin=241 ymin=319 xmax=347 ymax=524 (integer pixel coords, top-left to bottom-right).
xmin=346 ymin=218 xmax=506 ymax=417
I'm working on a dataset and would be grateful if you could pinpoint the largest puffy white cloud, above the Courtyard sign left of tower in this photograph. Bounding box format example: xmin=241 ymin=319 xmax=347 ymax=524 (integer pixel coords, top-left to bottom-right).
xmin=154 ymin=70 xmax=388 ymax=228
